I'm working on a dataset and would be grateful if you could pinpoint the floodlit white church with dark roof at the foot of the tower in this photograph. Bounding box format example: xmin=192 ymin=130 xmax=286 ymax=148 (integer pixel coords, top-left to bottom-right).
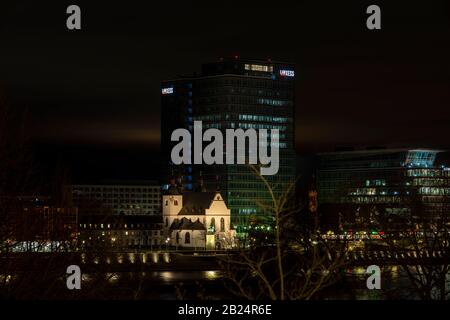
xmin=162 ymin=186 xmax=236 ymax=250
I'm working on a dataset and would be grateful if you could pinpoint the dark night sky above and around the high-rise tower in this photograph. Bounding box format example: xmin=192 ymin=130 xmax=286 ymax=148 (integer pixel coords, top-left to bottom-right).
xmin=0 ymin=0 xmax=450 ymax=180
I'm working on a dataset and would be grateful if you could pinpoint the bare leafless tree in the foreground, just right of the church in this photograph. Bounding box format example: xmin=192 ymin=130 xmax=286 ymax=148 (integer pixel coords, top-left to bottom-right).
xmin=221 ymin=169 xmax=347 ymax=300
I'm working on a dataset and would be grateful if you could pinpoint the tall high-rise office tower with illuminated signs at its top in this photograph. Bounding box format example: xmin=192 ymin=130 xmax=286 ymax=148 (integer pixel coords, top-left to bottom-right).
xmin=161 ymin=58 xmax=295 ymax=232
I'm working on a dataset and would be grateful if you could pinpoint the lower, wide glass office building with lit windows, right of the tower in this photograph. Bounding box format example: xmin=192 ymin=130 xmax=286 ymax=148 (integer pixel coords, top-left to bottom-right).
xmin=317 ymin=149 xmax=450 ymax=226
